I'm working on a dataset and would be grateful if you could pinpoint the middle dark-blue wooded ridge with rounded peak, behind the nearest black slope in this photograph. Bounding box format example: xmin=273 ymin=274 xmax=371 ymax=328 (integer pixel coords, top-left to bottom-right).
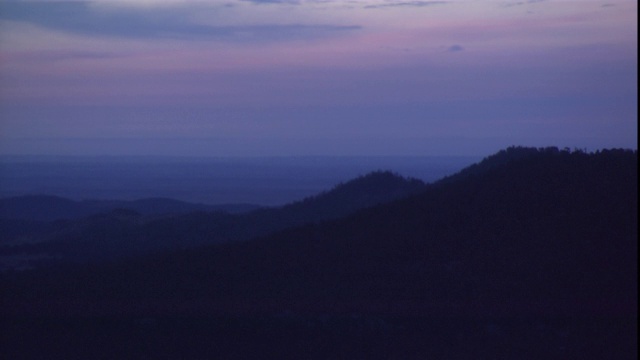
xmin=0 ymin=171 xmax=425 ymax=266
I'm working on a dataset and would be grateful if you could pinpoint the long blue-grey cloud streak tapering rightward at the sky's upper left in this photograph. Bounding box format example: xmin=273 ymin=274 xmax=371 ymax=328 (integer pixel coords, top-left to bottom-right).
xmin=0 ymin=2 xmax=361 ymax=43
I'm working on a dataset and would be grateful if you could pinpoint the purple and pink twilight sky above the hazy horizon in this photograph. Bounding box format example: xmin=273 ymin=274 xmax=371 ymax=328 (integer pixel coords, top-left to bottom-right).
xmin=0 ymin=0 xmax=638 ymax=157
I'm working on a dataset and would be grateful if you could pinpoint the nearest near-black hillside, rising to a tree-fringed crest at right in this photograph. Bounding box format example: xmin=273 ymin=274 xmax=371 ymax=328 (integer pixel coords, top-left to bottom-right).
xmin=2 ymin=148 xmax=637 ymax=359
